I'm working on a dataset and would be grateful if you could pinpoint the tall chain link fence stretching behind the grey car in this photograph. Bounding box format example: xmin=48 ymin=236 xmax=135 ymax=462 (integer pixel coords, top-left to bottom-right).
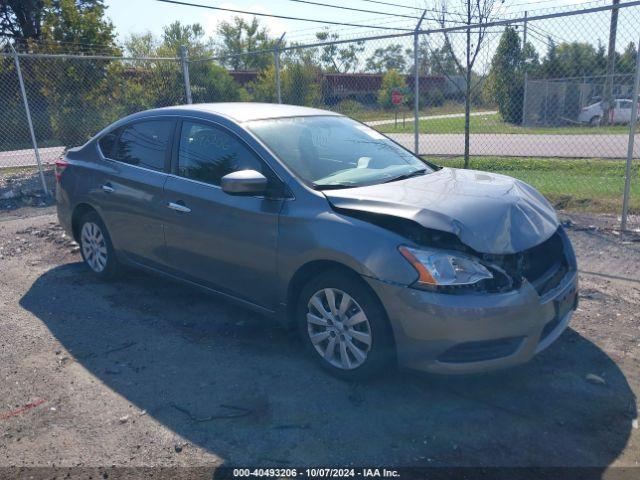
xmin=0 ymin=2 xmax=640 ymax=229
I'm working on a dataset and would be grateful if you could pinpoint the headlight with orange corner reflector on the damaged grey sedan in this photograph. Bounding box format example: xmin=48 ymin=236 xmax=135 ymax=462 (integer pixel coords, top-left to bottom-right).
xmin=399 ymin=246 xmax=493 ymax=287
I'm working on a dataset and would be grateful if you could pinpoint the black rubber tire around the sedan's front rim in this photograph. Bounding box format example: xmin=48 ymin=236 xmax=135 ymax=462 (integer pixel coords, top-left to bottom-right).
xmin=296 ymin=269 xmax=395 ymax=381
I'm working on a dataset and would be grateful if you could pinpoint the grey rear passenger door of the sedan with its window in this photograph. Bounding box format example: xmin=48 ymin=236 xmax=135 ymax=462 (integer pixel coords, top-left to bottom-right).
xmin=98 ymin=117 xmax=176 ymax=266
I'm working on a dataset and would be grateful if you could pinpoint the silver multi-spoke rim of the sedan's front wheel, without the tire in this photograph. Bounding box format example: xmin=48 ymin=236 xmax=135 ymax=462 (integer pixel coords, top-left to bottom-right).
xmin=307 ymin=288 xmax=372 ymax=370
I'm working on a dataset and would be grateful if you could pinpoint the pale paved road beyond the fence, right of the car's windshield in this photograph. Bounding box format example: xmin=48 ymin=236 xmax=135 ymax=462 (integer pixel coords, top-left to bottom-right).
xmin=389 ymin=133 xmax=640 ymax=158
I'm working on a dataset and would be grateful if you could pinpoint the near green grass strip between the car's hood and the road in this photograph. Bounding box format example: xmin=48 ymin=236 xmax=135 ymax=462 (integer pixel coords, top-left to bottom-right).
xmin=429 ymin=157 xmax=640 ymax=214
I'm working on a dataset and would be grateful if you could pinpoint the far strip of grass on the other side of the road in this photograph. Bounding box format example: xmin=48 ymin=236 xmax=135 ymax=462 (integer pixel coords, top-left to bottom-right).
xmin=374 ymin=112 xmax=629 ymax=135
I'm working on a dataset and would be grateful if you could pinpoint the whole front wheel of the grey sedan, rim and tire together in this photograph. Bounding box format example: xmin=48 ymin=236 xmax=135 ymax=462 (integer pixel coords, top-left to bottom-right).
xmin=297 ymin=270 xmax=394 ymax=380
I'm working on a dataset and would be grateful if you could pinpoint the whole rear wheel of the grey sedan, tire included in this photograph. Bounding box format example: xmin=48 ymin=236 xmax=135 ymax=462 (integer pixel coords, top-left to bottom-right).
xmin=78 ymin=212 xmax=118 ymax=279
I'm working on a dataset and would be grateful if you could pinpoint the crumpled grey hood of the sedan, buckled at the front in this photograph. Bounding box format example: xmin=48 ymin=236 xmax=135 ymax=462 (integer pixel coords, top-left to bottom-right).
xmin=323 ymin=168 xmax=558 ymax=254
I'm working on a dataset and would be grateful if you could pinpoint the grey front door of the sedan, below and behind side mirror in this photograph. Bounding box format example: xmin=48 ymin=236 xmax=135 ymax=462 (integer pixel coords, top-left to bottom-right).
xmin=164 ymin=119 xmax=284 ymax=310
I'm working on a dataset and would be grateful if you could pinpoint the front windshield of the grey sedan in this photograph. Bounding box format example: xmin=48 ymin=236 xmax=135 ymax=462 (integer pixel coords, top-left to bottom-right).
xmin=247 ymin=116 xmax=433 ymax=189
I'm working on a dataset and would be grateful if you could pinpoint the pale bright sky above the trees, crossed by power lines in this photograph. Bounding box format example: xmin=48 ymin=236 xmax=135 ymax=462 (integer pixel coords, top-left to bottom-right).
xmin=106 ymin=0 xmax=640 ymax=71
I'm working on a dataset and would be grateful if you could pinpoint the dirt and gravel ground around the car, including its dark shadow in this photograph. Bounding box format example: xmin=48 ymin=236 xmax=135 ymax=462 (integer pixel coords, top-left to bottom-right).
xmin=0 ymin=202 xmax=640 ymax=469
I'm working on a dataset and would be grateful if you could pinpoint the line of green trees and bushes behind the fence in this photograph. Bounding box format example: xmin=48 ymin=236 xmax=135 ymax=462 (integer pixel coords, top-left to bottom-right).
xmin=0 ymin=0 xmax=636 ymax=146
